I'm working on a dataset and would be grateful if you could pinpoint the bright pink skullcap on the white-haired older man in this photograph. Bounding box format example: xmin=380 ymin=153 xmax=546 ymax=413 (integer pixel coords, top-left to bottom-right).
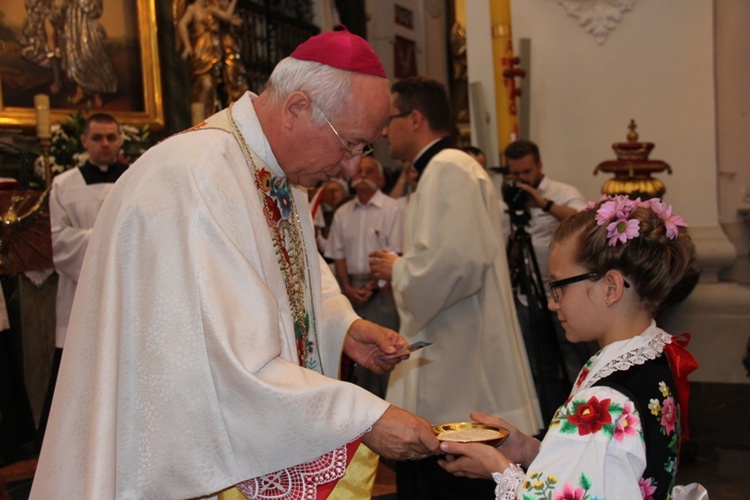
xmin=290 ymin=28 xmax=386 ymax=78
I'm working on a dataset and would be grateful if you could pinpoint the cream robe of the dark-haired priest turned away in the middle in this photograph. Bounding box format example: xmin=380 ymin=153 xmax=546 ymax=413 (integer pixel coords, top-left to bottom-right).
xmin=386 ymin=149 xmax=541 ymax=434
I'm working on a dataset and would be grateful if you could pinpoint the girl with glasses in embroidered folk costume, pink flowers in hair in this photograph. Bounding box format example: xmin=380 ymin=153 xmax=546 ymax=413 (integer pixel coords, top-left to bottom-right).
xmin=440 ymin=196 xmax=708 ymax=499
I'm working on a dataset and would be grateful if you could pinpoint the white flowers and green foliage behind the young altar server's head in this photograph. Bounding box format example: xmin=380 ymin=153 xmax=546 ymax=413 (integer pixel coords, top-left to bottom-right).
xmin=34 ymin=110 xmax=152 ymax=185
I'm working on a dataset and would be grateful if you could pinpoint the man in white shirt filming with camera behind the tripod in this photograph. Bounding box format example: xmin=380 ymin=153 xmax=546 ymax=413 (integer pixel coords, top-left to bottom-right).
xmin=503 ymin=139 xmax=592 ymax=419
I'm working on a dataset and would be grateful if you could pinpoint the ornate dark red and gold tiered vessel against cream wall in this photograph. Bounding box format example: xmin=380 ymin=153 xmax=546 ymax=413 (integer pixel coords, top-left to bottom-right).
xmin=594 ymin=120 xmax=672 ymax=200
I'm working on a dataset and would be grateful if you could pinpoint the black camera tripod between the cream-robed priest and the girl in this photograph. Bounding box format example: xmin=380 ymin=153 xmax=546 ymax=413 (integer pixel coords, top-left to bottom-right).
xmin=507 ymin=209 xmax=571 ymax=422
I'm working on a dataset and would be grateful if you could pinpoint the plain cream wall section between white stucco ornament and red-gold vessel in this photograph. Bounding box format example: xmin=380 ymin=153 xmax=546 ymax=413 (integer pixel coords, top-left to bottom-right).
xmin=511 ymin=0 xmax=718 ymax=226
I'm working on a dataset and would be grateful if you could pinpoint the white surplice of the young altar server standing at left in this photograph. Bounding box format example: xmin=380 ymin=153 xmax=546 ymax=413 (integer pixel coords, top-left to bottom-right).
xmin=49 ymin=168 xmax=114 ymax=349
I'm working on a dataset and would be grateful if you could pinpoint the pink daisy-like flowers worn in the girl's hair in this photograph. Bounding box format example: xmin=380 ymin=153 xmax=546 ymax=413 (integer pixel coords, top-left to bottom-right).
xmin=587 ymin=195 xmax=688 ymax=247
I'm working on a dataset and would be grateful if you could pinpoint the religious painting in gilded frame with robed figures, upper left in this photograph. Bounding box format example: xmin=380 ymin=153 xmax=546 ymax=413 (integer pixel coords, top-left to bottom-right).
xmin=0 ymin=0 xmax=164 ymax=128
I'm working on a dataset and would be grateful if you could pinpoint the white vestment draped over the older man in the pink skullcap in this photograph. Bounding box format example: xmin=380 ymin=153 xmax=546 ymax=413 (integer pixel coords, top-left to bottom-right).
xmin=31 ymin=94 xmax=388 ymax=500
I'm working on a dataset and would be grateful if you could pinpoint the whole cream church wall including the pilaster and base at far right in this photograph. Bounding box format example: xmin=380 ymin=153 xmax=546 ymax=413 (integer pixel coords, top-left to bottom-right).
xmin=466 ymin=0 xmax=750 ymax=384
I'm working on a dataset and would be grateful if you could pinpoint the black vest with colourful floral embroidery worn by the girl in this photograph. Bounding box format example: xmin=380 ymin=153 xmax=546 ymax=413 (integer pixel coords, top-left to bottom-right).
xmin=594 ymin=354 xmax=681 ymax=499
